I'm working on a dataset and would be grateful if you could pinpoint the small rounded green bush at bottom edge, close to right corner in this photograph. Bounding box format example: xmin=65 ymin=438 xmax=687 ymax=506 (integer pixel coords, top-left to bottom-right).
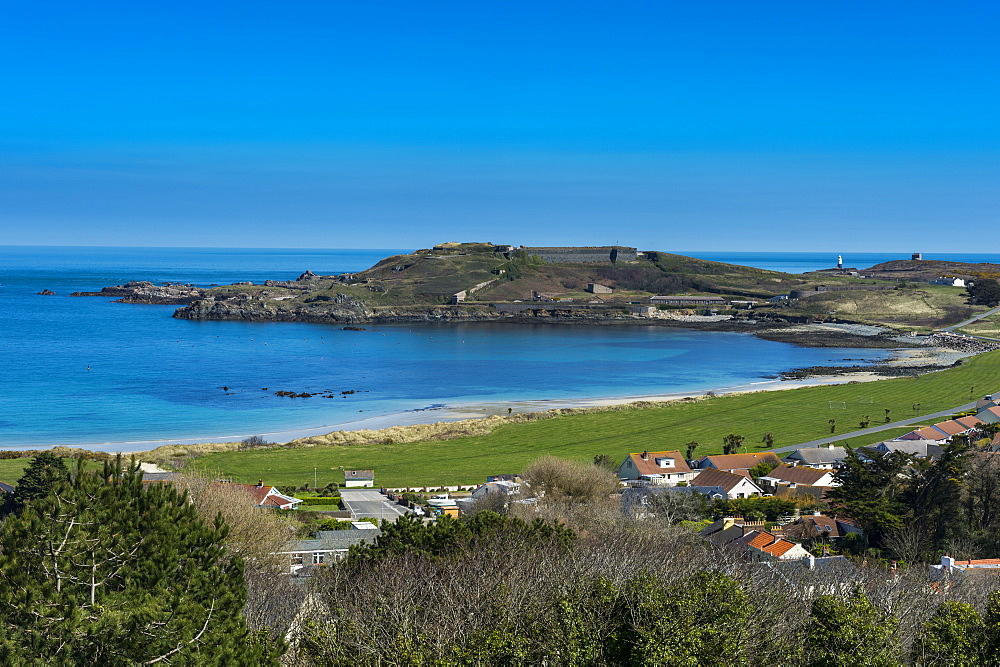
xmin=910 ymin=600 xmax=990 ymax=667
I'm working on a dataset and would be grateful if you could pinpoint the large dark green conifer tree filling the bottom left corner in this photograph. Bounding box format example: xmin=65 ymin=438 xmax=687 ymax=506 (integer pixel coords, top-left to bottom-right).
xmin=0 ymin=458 xmax=277 ymax=665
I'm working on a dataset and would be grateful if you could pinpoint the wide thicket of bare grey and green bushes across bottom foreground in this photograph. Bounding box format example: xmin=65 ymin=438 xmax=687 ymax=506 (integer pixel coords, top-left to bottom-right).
xmin=289 ymin=512 xmax=1000 ymax=665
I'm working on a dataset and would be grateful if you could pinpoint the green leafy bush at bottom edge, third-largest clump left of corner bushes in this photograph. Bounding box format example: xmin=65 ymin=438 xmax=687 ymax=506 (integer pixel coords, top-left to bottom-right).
xmin=805 ymin=586 xmax=900 ymax=667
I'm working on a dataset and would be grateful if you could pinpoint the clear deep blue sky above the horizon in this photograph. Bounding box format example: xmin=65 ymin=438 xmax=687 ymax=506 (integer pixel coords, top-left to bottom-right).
xmin=0 ymin=0 xmax=1000 ymax=252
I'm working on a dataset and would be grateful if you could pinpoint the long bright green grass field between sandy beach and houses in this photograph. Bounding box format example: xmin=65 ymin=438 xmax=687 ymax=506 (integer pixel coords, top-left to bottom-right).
xmin=192 ymin=352 xmax=1000 ymax=486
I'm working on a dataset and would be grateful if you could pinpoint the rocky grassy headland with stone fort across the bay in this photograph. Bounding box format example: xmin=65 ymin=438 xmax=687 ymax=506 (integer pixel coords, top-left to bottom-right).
xmin=74 ymin=243 xmax=1000 ymax=347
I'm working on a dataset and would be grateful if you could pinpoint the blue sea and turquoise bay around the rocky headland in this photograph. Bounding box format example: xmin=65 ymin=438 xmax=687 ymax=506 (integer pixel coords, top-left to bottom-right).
xmin=0 ymin=246 xmax=1000 ymax=452
